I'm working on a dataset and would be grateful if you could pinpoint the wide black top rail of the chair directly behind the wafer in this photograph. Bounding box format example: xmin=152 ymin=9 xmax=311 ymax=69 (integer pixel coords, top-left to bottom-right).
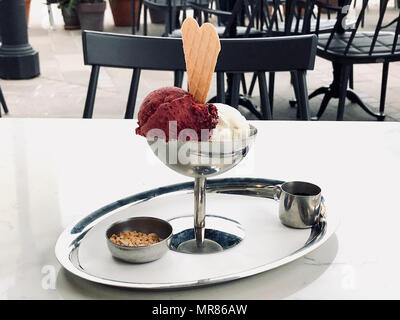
xmin=82 ymin=31 xmax=316 ymax=72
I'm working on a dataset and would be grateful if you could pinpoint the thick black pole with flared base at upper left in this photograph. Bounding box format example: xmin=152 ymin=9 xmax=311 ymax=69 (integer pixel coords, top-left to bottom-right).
xmin=0 ymin=0 xmax=40 ymax=79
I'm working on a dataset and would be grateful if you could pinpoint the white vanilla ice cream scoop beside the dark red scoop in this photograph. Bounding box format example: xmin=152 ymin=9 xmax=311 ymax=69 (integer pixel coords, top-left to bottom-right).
xmin=210 ymin=103 xmax=250 ymax=141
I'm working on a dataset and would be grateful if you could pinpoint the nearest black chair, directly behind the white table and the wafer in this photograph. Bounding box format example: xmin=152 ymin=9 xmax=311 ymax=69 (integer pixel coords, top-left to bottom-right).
xmin=82 ymin=31 xmax=317 ymax=120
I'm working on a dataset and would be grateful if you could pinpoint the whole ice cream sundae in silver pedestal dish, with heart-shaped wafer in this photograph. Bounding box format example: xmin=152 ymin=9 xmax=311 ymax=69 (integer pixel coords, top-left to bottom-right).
xmin=136 ymin=18 xmax=257 ymax=253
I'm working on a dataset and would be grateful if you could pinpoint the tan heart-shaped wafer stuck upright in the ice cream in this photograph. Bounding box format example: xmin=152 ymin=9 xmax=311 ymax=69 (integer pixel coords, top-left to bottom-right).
xmin=182 ymin=18 xmax=221 ymax=103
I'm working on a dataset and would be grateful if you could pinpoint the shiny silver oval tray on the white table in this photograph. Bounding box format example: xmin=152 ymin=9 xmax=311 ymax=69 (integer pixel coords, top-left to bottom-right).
xmin=55 ymin=178 xmax=339 ymax=289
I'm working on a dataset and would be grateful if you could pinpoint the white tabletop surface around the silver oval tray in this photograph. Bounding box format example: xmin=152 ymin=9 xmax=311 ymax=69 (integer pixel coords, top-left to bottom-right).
xmin=0 ymin=119 xmax=400 ymax=299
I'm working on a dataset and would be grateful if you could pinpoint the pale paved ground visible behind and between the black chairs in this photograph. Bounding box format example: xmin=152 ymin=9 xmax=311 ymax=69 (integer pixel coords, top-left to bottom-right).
xmin=0 ymin=0 xmax=400 ymax=121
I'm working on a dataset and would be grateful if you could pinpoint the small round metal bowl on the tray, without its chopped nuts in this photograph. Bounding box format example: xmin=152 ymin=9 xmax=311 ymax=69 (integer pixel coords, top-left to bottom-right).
xmin=106 ymin=217 xmax=172 ymax=263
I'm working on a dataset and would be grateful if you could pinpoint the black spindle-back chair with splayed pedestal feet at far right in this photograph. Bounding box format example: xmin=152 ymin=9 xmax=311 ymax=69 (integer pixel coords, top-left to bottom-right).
xmin=309 ymin=0 xmax=400 ymax=121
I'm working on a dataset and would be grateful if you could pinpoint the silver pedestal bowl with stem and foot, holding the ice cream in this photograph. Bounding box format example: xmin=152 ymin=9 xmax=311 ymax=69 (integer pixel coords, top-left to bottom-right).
xmin=147 ymin=125 xmax=257 ymax=253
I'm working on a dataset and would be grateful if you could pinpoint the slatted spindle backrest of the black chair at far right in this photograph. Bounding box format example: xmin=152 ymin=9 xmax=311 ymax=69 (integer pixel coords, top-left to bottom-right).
xmin=316 ymin=0 xmax=400 ymax=56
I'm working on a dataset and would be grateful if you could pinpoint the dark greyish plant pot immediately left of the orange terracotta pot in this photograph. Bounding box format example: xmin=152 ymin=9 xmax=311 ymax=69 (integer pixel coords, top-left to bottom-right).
xmin=78 ymin=2 xmax=106 ymax=31
